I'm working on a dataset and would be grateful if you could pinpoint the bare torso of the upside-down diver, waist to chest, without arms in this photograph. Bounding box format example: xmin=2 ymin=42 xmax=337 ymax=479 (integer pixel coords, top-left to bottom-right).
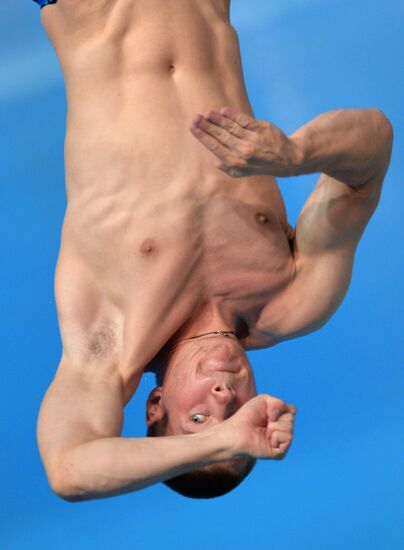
xmin=42 ymin=0 xmax=293 ymax=380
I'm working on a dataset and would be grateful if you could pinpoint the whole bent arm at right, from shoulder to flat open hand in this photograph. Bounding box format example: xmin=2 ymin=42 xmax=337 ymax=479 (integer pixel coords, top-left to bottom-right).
xmin=191 ymin=107 xmax=393 ymax=338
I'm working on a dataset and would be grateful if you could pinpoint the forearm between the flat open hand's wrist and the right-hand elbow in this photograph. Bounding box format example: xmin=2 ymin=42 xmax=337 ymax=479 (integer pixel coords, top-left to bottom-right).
xmin=289 ymin=109 xmax=393 ymax=187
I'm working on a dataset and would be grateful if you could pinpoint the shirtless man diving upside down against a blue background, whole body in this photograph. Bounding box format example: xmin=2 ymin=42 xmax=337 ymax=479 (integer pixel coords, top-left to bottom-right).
xmin=37 ymin=0 xmax=392 ymax=501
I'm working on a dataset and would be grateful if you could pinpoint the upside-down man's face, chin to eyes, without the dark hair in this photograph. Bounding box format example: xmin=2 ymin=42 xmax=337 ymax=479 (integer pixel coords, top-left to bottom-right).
xmin=148 ymin=335 xmax=257 ymax=435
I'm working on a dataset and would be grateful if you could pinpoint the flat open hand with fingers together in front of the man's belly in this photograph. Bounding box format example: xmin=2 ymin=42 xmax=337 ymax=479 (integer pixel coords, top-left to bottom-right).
xmin=190 ymin=107 xmax=300 ymax=178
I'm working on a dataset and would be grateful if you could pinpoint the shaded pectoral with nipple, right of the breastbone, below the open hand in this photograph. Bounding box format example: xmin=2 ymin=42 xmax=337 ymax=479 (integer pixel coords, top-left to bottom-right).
xmin=202 ymin=197 xmax=293 ymax=310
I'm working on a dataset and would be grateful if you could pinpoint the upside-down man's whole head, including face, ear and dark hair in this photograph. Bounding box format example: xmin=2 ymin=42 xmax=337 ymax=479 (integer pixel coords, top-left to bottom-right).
xmin=146 ymin=335 xmax=257 ymax=498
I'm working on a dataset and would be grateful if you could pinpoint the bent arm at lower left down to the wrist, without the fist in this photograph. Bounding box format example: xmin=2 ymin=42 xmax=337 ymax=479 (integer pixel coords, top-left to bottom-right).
xmin=38 ymin=360 xmax=234 ymax=501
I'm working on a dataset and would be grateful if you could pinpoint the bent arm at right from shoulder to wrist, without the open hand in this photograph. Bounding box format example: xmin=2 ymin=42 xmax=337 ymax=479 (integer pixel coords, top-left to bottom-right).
xmin=262 ymin=109 xmax=393 ymax=339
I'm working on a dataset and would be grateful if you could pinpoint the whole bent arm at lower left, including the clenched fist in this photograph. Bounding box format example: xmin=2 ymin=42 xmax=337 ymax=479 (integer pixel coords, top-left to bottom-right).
xmin=38 ymin=362 xmax=291 ymax=502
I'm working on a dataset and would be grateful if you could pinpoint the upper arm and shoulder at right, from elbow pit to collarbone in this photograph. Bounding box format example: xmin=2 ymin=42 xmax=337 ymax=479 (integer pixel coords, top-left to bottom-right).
xmin=260 ymin=168 xmax=384 ymax=340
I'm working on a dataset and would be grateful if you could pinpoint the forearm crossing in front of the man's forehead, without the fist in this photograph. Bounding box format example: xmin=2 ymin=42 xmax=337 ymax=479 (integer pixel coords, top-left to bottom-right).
xmin=54 ymin=428 xmax=234 ymax=501
